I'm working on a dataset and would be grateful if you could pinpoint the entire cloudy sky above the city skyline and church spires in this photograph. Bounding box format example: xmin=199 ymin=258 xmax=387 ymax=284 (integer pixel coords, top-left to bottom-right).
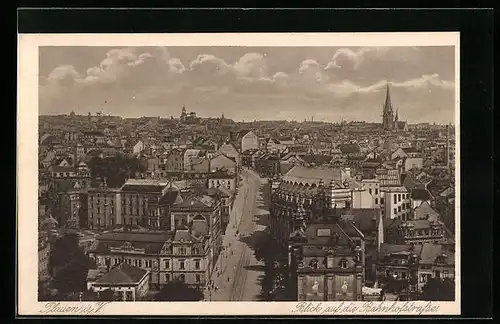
xmin=39 ymin=47 xmax=455 ymax=123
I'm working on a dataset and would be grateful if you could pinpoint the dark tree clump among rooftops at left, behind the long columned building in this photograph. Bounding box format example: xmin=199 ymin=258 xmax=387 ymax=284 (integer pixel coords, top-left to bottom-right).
xmin=88 ymin=154 xmax=146 ymax=188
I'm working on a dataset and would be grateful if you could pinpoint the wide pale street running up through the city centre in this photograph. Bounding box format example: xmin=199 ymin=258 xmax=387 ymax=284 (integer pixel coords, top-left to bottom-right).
xmin=205 ymin=169 xmax=268 ymax=301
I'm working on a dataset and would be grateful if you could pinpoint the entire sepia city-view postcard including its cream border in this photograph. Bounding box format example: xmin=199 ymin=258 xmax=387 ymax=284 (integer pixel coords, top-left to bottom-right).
xmin=18 ymin=33 xmax=460 ymax=315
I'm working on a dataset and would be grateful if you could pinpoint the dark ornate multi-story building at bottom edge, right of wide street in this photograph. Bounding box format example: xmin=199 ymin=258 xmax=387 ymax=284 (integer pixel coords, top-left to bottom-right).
xmin=289 ymin=209 xmax=365 ymax=301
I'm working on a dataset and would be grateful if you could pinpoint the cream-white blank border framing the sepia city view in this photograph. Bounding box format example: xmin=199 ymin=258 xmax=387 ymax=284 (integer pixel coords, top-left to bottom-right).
xmin=17 ymin=32 xmax=461 ymax=316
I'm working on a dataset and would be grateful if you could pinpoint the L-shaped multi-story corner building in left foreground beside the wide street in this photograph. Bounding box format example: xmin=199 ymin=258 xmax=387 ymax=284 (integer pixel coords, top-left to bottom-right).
xmin=89 ymin=199 xmax=222 ymax=289
